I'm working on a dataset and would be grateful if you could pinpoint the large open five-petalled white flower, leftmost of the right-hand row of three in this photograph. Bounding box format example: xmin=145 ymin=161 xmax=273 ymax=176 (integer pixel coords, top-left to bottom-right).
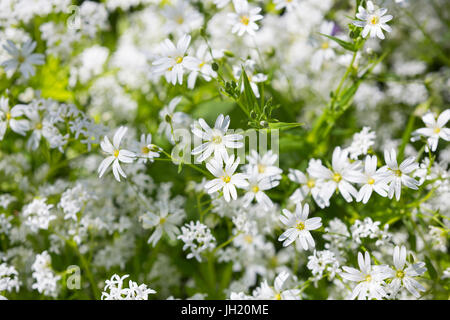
xmin=309 ymin=147 xmax=361 ymax=202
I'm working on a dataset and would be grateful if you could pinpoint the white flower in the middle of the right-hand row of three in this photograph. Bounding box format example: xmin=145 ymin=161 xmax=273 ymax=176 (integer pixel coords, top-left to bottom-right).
xmin=356 ymin=156 xmax=389 ymax=203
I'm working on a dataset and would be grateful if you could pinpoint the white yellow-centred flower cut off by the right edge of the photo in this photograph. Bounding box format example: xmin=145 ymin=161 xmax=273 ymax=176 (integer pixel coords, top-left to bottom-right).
xmin=413 ymin=109 xmax=450 ymax=152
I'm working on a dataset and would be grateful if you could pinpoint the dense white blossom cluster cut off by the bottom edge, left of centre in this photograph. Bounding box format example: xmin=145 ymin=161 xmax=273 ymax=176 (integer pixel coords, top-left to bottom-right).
xmin=101 ymin=274 xmax=156 ymax=300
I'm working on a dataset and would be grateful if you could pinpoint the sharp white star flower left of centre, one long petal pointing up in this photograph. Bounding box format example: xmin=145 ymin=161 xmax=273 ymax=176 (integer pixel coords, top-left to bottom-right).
xmin=98 ymin=127 xmax=136 ymax=182
